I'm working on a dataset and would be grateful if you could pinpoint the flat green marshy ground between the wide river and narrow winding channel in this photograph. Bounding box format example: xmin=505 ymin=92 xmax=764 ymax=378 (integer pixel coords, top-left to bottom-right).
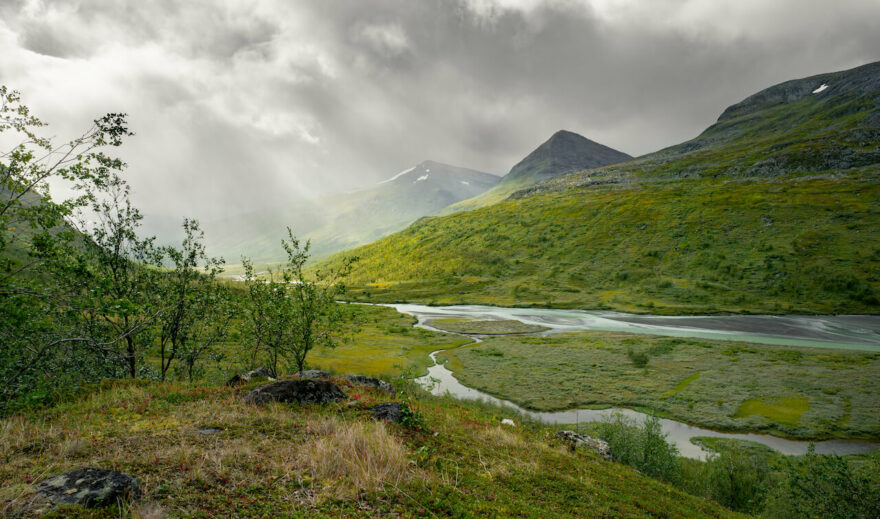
xmin=441 ymin=332 xmax=880 ymax=438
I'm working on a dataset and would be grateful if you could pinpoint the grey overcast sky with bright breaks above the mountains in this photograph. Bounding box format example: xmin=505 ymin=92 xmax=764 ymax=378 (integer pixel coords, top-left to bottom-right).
xmin=0 ymin=0 xmax=880 ymax=228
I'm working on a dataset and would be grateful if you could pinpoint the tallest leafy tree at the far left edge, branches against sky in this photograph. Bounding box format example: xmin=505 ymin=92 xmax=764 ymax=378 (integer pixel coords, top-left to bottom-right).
xmin=0 ymin=86 xmax=131 ymax=414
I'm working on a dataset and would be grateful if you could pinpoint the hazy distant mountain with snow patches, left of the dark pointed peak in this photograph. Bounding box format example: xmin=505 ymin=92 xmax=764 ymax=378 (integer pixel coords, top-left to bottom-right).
xmin=204 ymin=160 xmax=498 ymax=263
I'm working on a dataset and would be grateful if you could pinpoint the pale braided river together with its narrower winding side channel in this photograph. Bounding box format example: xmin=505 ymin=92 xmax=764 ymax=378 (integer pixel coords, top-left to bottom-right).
xmin=383 ymin=304 xmax=880 ymax=459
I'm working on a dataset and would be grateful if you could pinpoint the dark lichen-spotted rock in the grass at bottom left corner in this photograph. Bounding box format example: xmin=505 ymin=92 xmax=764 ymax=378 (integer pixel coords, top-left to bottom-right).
xmin=37 ymin=467 xmax=140 ymax=507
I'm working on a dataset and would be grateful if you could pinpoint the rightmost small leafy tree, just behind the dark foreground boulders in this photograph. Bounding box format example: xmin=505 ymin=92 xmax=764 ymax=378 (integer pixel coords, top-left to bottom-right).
xmin=242 ymin=228 xmax=356 ymax=375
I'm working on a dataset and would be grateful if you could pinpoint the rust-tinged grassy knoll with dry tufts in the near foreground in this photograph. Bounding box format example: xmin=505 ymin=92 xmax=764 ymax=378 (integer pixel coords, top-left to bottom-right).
xmin=0 ymin=381 xmax=737 ymax=518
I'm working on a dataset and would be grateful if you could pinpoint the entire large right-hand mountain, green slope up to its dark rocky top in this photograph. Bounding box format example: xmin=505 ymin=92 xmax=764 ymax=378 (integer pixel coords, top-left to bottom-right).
xmin=316 ymin=59 xmax=880 ymax=314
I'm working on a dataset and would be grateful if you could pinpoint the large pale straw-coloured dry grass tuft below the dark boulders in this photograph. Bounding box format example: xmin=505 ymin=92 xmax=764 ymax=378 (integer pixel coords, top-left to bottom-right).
xmin=302 ymin=417 xmax=410 ymax=497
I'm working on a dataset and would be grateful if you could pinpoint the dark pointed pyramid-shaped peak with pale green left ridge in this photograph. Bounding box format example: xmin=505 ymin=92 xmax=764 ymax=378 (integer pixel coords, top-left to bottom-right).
xmin=442 ymin=130 xmax=632 ymax=214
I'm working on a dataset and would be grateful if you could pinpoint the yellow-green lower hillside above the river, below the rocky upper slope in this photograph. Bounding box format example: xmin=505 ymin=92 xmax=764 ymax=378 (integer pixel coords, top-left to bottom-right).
xmin=326 ymin=175 xmax=880 ymax=313
